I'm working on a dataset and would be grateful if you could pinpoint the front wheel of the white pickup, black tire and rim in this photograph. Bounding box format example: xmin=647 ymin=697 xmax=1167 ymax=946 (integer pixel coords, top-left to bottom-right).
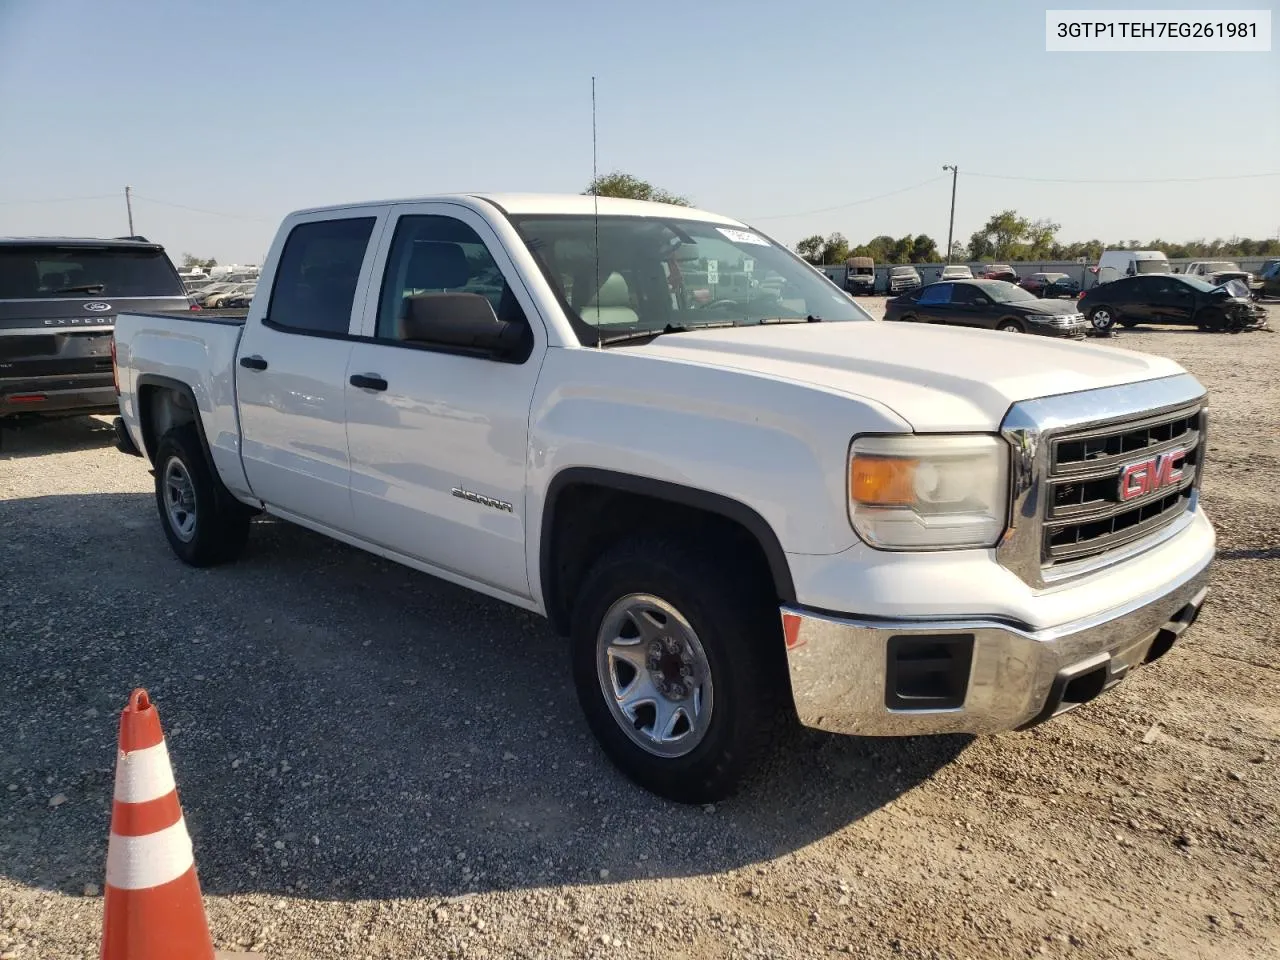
xmin=571 ymin=538 xmax=786 ymax=803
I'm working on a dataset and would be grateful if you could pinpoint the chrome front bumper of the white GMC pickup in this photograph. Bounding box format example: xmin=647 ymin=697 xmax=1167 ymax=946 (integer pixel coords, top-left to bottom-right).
xmin=782 ymin=563 xmax=1210 ymax=736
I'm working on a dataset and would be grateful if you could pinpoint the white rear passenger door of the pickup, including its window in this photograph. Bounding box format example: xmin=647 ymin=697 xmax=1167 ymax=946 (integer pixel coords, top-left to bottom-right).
xmin=236 ymin=207 xmax=385 ymax=532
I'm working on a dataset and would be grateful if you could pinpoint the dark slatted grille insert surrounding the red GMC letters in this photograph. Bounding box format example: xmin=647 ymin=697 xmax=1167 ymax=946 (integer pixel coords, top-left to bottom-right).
xmin=1041 ymin=402 xmax=1204 ymax=570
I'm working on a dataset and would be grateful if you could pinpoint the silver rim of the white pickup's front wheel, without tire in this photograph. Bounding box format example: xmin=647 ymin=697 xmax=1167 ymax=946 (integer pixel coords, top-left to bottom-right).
xmin=595 ymin=594 xmax=716 ymax=758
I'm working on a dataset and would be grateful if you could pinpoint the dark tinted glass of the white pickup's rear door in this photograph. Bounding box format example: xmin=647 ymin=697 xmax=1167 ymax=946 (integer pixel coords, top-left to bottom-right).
xmin=266 ymin=216 xmax=376 ymax=335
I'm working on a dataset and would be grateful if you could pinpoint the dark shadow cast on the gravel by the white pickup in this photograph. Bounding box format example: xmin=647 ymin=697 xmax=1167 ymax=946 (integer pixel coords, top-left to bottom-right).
xmin=0 ymin=491 xmax=969 ymax=900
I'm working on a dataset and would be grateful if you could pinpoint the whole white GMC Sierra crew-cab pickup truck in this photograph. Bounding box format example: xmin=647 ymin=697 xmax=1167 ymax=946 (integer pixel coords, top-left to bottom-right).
xmin=114 ymin=196 xmax=1213 ymax=801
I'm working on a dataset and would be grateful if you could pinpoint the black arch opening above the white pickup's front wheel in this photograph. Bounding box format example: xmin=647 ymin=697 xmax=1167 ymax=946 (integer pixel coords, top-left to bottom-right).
xmin=539 ymin=467 xmax=795 ymax=634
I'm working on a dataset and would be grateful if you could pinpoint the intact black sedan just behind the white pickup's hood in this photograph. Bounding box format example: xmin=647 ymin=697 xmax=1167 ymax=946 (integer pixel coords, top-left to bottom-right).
xmin=884 ymin=280 xmax=1088 ymax=338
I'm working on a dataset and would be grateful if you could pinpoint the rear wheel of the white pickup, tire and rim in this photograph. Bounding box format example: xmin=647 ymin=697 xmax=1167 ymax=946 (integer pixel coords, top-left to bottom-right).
xmin=155 ymin=424 xmax=251 ymax=567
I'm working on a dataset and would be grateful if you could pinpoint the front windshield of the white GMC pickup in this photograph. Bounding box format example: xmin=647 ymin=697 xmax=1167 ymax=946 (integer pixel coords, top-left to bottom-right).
xmin=511 ymin=215 xmax=870 ymax=344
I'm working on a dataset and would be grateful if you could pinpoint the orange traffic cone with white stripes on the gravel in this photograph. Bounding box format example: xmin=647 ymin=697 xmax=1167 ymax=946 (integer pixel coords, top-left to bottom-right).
xmin=101 ymin=690 xmax=214 ymax=960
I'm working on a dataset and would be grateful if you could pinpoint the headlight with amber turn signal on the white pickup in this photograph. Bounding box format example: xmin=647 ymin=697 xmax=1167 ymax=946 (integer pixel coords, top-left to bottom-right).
xmin=849 ymin=434 xmax=1009 ymax=550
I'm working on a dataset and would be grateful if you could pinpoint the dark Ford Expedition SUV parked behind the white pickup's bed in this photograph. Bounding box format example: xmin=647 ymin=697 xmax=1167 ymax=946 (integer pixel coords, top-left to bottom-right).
xmin=0 ymin=237 xmax=191 ymax=424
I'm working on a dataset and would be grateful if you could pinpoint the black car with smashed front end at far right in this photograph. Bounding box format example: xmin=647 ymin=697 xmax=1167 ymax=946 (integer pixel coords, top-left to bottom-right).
xmin=1078 ymin=274 xmax=1267 ymax=333
